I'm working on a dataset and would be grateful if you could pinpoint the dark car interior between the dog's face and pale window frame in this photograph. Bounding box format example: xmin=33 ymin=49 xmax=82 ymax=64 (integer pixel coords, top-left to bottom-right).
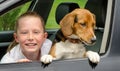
xmin=85 ymin=0 xmax=108 ymax=53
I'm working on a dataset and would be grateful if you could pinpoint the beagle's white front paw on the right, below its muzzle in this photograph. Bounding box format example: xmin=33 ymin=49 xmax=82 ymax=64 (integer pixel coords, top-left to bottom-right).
xmin=86 ymin=51 xmax=100 ymax=63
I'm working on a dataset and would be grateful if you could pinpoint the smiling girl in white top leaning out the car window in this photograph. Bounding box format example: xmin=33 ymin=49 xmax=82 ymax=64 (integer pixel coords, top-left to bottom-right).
xmin=1 ymin=12 xmax=52 ymax=63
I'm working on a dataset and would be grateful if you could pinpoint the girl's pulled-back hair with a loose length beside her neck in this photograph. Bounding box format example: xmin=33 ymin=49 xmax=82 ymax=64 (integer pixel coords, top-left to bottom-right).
xmin=7 ymin=11 xmax=45 ymax=52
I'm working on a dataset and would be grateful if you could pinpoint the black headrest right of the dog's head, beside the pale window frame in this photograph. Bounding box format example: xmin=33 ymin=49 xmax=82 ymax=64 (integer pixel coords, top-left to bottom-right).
xmin=85 ymin=0 xmax=107 ymax=28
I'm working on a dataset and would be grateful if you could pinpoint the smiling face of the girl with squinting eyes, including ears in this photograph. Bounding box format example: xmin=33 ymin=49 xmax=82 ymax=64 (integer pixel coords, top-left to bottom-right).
xmin=14 ymin=16 xmax=47 ymax=53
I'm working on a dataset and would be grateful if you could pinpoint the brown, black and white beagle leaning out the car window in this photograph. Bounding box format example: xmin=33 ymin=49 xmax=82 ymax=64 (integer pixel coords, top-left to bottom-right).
xmin=41 ymin=9 xmax=100 ymax=64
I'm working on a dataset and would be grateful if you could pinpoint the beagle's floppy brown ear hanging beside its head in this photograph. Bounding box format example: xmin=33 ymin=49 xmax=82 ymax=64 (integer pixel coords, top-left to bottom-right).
xmin=60 ymin=13 xmax=75 ymax=36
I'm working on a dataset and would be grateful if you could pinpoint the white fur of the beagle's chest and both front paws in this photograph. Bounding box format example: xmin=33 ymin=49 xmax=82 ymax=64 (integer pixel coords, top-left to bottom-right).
xmin=41 ymin=36 xmax=100 ymax=64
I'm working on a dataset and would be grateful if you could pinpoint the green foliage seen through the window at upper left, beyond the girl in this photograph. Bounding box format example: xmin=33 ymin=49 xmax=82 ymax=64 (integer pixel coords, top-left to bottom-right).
xmin=0 ymin=2 xmax=31 ymax=31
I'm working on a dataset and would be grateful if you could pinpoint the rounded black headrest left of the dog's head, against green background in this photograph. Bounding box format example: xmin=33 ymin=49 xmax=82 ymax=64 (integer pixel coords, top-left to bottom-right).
xmin=55 ymin=2 xmax=79 ymax=24
